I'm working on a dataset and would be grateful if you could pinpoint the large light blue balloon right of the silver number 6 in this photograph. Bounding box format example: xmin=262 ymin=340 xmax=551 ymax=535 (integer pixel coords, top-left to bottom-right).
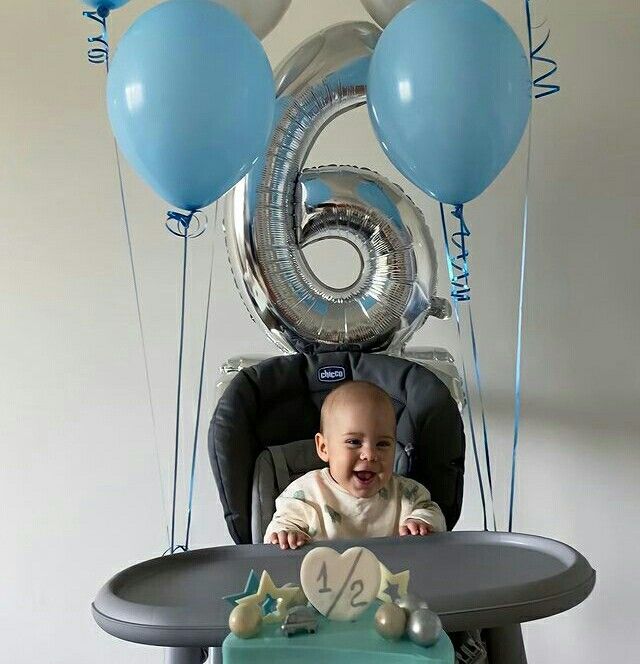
xmin=367 ymin=0 xmax=531 ymax=204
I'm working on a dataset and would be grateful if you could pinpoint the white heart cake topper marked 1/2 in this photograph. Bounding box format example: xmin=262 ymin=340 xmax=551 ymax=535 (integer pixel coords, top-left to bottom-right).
xmin=300 ymin=546 xmax=380 ymax=620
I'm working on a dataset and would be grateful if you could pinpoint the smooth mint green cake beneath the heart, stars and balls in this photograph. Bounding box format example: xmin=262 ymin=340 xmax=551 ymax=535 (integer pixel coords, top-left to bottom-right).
xmin=222 ymin=602 xmax=455 ymax=664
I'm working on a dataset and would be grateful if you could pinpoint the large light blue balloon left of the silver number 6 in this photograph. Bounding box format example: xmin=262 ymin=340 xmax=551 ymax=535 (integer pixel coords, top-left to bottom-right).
xmin=107 ymin=0 xmax=275 ymax=210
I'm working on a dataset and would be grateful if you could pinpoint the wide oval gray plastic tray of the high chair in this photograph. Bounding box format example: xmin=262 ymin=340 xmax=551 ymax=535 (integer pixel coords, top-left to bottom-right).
xmin=92 ymin=532 xmax=595 ymax=648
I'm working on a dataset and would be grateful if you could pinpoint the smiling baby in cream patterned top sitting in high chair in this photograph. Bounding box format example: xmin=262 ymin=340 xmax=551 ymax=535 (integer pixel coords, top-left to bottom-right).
xmin=264 ymin=381 xmax=446 ymax=549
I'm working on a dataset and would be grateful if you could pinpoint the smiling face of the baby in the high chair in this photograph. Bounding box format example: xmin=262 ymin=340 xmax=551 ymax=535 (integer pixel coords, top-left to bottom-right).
xmin=316 ymin=396 xmax=396 ymax=498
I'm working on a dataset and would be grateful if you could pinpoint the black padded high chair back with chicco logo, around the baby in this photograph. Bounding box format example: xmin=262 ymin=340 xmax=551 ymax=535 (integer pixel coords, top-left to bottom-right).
xmin=209 ymin=351 xmax=465 ymax=544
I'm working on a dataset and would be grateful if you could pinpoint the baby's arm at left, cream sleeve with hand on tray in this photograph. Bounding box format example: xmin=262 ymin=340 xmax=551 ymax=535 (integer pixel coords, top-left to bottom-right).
xmin=264 ymin=487 xmax=318 ymax=549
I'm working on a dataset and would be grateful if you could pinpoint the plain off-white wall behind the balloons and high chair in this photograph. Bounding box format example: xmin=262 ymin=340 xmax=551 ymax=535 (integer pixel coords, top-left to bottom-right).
xmin=0 ymin=0 xmax=640 ymax=664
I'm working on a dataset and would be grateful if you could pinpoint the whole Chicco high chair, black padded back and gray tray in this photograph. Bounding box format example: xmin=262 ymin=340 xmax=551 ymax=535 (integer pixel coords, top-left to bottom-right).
xmin=92 ymin=351 xmax=595 ymax=664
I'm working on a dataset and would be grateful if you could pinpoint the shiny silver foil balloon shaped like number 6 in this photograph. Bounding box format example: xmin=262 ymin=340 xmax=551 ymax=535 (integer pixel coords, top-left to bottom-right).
xmin=225 ymin=22 xmax=450 ymax=354
